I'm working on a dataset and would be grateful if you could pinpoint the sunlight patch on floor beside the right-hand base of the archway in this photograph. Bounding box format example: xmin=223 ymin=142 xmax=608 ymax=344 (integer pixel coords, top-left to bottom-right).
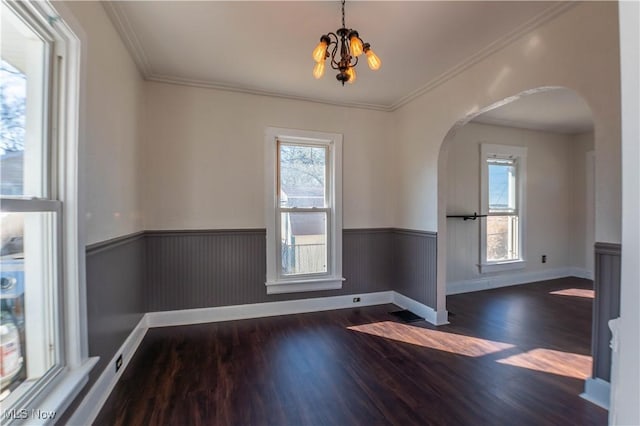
xmin=497 ymin=348 xmax=592 ymax=379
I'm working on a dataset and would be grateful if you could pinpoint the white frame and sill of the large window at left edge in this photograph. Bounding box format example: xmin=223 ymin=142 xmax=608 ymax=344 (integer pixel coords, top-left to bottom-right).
xmin=2 ymin=1 xmax=98 ymax=424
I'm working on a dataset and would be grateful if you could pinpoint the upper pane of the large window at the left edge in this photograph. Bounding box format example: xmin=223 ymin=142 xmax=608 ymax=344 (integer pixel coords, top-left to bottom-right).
xmin=0 ymin=2 xmax=47 ymax=197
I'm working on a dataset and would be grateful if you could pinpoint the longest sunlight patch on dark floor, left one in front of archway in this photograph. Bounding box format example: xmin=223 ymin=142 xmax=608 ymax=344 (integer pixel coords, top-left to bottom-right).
xmin=347 ymin=321 xmax=514 ymax=357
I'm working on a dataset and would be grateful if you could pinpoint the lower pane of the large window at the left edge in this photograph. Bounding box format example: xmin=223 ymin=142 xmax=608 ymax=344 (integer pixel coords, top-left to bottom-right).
xmin=0 ymin=212 xmax=57 ymax=400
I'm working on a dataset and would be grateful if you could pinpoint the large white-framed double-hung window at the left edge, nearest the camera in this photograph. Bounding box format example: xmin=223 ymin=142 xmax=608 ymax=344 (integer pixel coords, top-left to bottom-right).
xmin=0 ymin=1 xmax=93 ymax=424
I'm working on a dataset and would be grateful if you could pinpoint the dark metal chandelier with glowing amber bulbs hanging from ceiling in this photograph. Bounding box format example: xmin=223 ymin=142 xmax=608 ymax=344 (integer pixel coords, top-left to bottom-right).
xmin=313 ymin=0 xmax=382 ymax=86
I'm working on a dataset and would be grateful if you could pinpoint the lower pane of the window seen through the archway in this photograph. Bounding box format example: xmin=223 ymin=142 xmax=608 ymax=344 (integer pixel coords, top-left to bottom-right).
xmin=487 ymin=216 xmax=519 ymax=262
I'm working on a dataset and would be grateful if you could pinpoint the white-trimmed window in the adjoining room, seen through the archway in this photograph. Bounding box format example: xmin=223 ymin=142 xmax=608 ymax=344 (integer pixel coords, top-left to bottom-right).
xmin=480 ymin=144 xmax=527 ymax=272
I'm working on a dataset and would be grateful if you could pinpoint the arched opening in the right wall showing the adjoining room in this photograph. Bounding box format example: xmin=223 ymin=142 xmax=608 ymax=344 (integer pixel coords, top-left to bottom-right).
xmin=437 ymin=87 xmax=610 ymax=406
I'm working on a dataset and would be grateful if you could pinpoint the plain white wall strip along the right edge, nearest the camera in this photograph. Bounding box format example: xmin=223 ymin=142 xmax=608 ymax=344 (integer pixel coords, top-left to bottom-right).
xmin=609 ymin=1 xmax=640 ymax=425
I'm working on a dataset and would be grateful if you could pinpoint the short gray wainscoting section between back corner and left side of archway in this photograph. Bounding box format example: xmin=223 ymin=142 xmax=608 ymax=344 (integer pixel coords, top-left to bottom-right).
xmin=393 ymin=229 xmax=438 ymax=309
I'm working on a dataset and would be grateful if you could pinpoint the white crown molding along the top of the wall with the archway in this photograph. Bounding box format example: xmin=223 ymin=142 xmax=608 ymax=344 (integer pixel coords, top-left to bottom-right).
xmin=389 ymin=1 xmax=578 ymax=111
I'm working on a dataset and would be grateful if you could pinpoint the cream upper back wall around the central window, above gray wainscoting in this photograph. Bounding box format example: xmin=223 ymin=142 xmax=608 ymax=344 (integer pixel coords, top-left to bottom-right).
xmin=143 ymin=83 xmax=394 ymax=229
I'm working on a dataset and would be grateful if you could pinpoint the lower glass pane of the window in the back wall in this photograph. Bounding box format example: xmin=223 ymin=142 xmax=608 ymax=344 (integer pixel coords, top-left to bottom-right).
xmin=280 ymin=212 xmax=327 ymax=275
